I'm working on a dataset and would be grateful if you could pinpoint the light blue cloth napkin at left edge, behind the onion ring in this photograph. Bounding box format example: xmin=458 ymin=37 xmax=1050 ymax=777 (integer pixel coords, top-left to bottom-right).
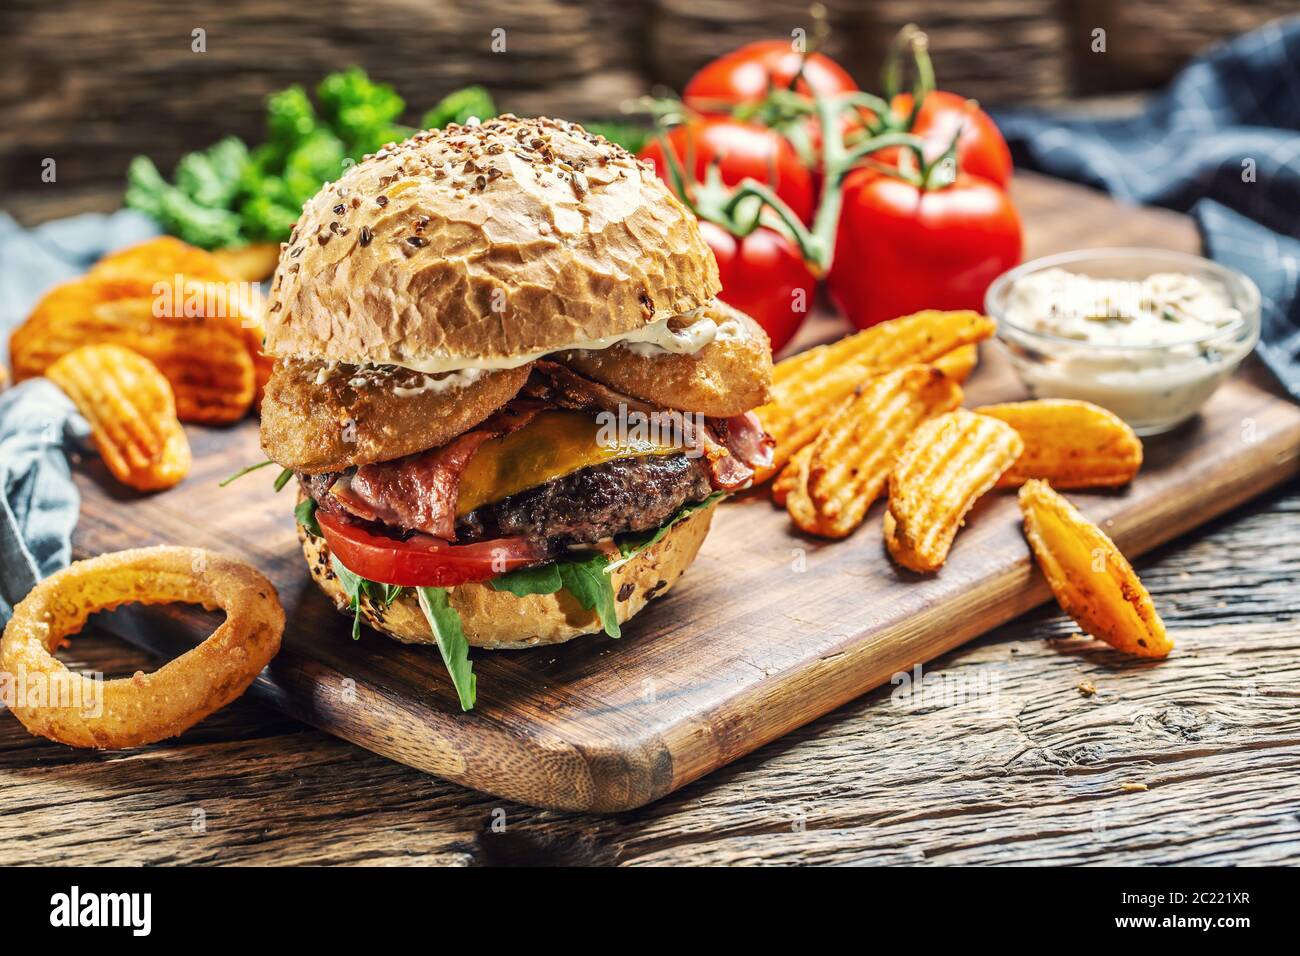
xmin=0 ymin=212 xmax=159 ymax=624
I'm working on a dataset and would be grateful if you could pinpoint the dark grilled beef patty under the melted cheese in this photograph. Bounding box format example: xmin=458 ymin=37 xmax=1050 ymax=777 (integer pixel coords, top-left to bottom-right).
xmin=298 ymin=454 xmax=712 ymax=548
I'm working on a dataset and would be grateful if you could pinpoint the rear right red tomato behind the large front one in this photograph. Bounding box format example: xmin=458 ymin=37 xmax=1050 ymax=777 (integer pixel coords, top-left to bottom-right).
xmin=876 ymin=90 xmax=1011 ymax=189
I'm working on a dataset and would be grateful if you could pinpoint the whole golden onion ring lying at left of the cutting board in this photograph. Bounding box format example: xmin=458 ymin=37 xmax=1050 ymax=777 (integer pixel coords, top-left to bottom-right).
xmin=0 ymin=546 xmax=285 ymax=749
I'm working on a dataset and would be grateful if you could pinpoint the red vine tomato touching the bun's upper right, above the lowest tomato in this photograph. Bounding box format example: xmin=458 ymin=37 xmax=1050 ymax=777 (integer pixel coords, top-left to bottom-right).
xmin=638 ymin=118 xmax=814 ymax=222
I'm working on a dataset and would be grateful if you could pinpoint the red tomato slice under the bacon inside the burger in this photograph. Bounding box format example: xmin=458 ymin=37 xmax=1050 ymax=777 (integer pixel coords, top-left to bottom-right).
xmin=316 ymin=509 xmax=546 ymax=588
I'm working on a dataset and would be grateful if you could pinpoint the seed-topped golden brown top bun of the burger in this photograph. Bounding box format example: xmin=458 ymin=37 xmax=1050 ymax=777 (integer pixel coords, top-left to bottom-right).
xmin=267 ymin=116 xmax=720 ymax=367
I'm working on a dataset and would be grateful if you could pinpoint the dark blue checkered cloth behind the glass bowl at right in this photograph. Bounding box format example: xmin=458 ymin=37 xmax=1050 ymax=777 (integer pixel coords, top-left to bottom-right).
xmin=995 ymin=17 xmax=1300 ymax=401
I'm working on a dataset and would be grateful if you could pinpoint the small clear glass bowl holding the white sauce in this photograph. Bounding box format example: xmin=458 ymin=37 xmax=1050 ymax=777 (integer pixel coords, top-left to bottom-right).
xmin=984 ymin=248 xmax=1260 ymax=434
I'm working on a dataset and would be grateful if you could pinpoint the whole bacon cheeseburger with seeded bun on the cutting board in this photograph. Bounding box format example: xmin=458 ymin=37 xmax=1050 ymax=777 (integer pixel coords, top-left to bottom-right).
xmin=261 ymin=116 xmax=772 ymax=709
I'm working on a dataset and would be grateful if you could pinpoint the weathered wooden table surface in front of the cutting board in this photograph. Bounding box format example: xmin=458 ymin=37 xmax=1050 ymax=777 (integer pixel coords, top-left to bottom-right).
xmin=0 ymin=177 xmax=1300 ymax=865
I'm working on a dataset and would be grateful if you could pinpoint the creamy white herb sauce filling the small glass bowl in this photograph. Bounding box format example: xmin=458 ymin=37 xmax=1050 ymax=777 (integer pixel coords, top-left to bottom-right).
xmin=1004 ymin=268 xmax=1255 ymax=434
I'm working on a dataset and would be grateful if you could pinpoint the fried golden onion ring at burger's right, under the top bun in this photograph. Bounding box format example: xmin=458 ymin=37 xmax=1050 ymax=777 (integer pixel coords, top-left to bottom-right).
xmin=556 ymin=300 xmax=772 ymax=419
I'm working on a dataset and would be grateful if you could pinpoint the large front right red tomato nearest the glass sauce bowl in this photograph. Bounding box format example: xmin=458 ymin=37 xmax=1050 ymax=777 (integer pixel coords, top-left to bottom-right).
xmin=828 ymin=169 xmax=1021 ymax=329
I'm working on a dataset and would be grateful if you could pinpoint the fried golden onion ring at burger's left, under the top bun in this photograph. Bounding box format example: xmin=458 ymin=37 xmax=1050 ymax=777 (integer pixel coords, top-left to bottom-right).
xmin=261 ymin=359 xmax=530 ymax=475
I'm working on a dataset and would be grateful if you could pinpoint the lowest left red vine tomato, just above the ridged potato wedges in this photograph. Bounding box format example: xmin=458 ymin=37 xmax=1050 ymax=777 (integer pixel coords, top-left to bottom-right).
xmin=699 ymin=222 xmax=816 ymax=352
